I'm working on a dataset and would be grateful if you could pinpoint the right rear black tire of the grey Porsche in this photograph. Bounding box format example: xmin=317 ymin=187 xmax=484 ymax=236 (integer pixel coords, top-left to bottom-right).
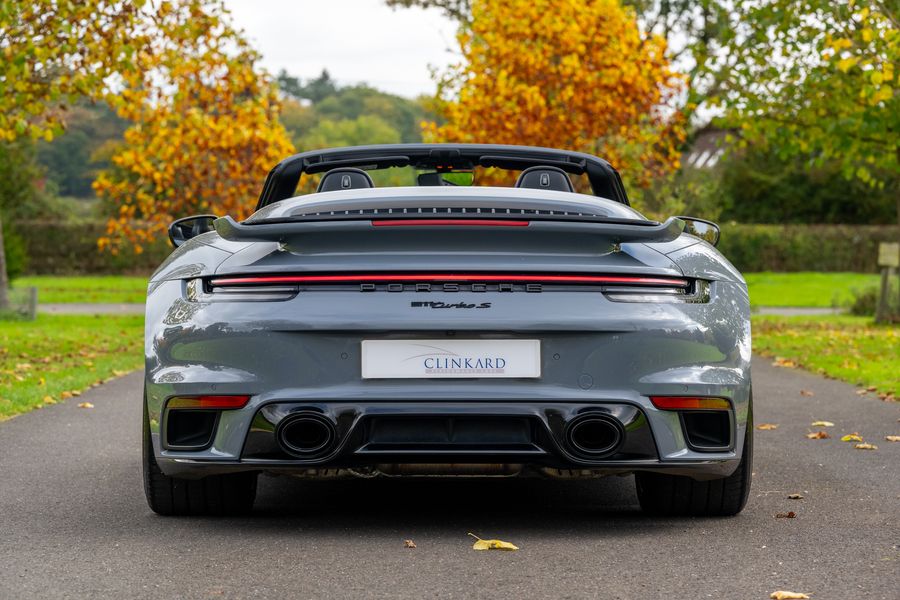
xmin=635 ymin=392 xmax=753 ymax=517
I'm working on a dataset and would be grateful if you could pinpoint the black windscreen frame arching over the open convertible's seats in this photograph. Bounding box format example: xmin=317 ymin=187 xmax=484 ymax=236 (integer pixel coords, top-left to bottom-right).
xmin=256 ymin=144 xmax=629 ymax=209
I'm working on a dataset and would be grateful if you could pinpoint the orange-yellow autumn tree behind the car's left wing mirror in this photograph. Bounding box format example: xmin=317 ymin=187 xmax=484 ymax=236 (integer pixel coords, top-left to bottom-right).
xmin=94 ymin=0 xmax=293 ymax=252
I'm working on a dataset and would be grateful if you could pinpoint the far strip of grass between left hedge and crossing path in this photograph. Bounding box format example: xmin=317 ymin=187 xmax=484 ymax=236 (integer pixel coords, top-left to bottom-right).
xmin=13 ymin=275 xmax=147 ymax=304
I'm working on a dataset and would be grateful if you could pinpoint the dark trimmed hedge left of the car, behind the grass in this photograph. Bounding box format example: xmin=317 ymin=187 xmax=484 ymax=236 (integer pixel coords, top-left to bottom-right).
xmin=12 ymin=221 xmax=172 ymax=275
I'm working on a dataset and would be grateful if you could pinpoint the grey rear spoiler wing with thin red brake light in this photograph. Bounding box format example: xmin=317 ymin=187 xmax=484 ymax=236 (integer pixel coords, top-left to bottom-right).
xmin=214 ymin=216 xmax=685 ymax=244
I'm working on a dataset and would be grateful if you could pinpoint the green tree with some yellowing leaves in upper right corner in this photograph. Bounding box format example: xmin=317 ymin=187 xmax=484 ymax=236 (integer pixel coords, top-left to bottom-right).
xmin=710 ymin=0 xmax=900 ymax=222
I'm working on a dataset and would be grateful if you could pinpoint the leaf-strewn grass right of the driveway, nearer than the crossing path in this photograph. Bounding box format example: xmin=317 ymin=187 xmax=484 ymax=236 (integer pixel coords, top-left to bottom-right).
xmin=753 ymin=315 xmax=900 ymax=397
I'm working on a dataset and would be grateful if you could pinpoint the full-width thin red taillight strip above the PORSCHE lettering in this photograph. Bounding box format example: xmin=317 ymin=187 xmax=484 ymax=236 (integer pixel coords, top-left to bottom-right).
xmin=210 ymin=273 xmax=688 ymax=287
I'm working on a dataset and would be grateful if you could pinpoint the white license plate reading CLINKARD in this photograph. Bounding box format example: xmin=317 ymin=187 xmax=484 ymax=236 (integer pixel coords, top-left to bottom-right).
xmin=362 ymin=339 xmax=541 ymax=379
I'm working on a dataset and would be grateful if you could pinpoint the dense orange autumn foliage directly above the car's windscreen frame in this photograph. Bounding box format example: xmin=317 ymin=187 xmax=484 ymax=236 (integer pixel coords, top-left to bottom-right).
xmin=425 ymin=0 xmax=684 ymax=190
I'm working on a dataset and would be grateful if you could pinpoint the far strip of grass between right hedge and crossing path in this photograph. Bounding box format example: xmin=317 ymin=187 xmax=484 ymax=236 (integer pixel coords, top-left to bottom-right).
xmin=744 ymin=272 xmax=879 ymax=307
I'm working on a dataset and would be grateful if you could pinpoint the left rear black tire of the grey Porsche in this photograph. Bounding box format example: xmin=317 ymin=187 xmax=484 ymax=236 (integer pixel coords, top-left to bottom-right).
xmin=142 ymin=398 xmax=257 ymax=516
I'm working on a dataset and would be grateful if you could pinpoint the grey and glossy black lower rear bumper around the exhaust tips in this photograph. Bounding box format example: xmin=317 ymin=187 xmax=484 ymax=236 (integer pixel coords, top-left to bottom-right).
xmin=157 ymin=400 xmax=740 ymax=479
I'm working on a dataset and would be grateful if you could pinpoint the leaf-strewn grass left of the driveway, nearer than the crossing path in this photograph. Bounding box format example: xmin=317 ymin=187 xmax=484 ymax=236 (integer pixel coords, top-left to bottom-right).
xmin=0 ymin=315 xmax=144 ymax=421
